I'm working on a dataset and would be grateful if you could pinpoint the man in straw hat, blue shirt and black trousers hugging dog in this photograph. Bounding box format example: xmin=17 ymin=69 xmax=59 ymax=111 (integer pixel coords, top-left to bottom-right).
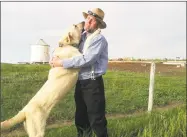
xmin=50 ymin=8 xmax=108 ymax=137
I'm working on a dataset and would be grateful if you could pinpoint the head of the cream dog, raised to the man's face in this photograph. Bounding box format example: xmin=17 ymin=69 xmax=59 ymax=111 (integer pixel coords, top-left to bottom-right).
xmin=59 ymin=22 xmax=84 ymax=47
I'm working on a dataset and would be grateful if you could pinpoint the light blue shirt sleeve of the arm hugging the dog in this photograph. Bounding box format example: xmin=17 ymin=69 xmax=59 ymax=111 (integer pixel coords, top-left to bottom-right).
xmin=62 ymin=35 xmax=107 ymax=68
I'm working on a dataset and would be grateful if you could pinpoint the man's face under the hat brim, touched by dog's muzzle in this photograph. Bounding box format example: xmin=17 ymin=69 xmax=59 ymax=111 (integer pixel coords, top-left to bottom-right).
xmin=84 ymin=15 xmax=97 ymax=33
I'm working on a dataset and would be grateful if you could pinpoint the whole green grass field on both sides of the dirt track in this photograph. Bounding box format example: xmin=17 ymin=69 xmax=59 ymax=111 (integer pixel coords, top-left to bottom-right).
xmin=1 ymin=64 xmax=186 ymax=137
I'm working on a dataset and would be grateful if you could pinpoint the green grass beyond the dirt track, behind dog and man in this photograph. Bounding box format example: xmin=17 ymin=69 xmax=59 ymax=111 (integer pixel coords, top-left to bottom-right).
xmin=1 ymin=64 xmax=186 ymax=121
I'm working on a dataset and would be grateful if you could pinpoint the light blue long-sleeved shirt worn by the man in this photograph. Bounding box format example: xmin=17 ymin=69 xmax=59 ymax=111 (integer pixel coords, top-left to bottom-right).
xmin=62 ymin=33 xmax=108 ymax=80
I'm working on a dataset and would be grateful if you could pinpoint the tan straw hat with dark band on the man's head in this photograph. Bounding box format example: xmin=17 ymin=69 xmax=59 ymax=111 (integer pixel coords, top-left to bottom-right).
xmin=83 ymin=8 xmax=107 ymax=29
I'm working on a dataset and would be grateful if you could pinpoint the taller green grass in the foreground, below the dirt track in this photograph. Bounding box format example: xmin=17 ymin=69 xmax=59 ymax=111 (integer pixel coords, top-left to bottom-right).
xmin=19 ymin=106 xmax=186 ymax=137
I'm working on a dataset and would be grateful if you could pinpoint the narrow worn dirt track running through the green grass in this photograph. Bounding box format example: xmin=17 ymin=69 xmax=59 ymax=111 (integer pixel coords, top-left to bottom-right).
xmin=1 ymin=103 xmax=185 ymax=137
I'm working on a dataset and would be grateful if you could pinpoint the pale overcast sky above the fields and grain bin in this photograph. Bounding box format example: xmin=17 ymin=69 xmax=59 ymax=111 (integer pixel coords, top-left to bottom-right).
xmin=1 ymin=2 xmax=186 ymax=63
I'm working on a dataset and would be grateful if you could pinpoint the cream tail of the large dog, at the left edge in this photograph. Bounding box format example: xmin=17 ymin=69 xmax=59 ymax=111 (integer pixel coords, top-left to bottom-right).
xmin=1 ymin=111 xmax=26 ymax=131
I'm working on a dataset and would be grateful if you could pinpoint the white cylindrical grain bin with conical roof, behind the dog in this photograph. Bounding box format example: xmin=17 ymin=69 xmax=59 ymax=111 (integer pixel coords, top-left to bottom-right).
xmin=30 ymin=39 xmax=50 ymax=64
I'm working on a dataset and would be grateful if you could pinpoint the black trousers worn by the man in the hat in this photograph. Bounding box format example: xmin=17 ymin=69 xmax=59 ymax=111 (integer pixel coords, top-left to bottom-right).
xmin=74 ymin=76 xmax=108 ymax=137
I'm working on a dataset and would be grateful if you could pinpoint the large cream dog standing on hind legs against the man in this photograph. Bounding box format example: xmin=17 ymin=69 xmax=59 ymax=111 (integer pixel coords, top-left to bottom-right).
xmin=1 ymin=22 xmax=100 ymax=137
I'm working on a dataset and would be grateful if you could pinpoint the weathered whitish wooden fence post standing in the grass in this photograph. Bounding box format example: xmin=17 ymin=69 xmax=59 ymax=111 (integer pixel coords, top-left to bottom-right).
xmin=148 ymin=62 xmax=155 ymax=112
